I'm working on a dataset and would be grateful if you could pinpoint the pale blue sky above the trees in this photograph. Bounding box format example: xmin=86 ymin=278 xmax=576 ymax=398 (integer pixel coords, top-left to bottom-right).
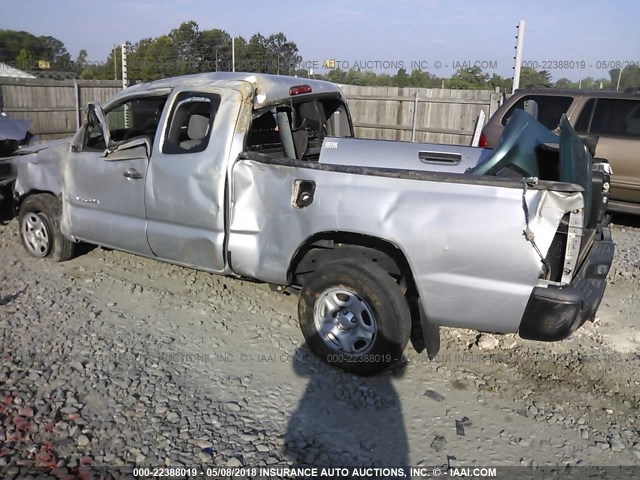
xmin=0 ymin=0 xmax=640 ymax=81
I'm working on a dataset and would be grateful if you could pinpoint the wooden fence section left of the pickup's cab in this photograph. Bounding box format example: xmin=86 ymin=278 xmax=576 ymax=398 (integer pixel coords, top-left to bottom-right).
xmin=0 ymin=77 xmax=122 ymax=139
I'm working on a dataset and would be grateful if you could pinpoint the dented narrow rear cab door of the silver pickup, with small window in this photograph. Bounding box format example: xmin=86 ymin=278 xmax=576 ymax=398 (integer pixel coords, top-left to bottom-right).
xmin=145 ymin=87 xmax=242 ymax=272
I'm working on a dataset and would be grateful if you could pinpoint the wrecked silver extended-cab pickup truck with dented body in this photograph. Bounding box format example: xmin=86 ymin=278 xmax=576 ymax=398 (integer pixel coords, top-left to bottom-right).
xmin=14 ymin=73 xmax=614 ymax=375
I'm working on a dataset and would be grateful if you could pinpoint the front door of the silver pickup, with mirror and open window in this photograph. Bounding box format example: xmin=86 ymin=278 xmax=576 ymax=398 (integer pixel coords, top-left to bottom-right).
xmin=62 ymin=96 xmax=166 ymax=256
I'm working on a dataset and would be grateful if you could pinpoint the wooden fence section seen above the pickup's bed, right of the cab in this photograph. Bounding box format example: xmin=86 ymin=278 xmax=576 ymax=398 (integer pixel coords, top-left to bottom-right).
xmin=340 ymin=85 xmax=501 ymax=145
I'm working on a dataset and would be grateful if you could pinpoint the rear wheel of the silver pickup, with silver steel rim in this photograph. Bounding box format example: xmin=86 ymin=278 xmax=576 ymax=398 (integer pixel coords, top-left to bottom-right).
xmin=298 ymin=259 xmax=411 ymax=375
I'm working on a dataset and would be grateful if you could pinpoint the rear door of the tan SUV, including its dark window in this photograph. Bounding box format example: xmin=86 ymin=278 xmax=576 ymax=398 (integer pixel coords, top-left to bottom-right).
xmin=575 ymin=98 xmax=640 ymax=203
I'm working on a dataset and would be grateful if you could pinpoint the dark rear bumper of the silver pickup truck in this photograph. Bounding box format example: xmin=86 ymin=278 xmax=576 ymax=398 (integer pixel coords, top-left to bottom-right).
xmin=518 ymin=227 xmax=615 ymax=341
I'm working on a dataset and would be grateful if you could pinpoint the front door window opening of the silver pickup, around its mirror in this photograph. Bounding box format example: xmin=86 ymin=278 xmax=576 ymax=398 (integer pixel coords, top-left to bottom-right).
xmin=85 ymin=96 xmax=167 ymax=150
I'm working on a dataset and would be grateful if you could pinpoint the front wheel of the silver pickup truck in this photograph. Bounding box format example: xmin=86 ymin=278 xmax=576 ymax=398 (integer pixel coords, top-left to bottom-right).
xmin=18 ymin=194 xmax=75 ymax=262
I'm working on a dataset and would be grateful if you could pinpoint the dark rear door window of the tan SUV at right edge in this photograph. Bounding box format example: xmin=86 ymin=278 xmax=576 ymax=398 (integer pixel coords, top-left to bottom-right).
xmin=589 ymin=98 xmax=640 ymax=138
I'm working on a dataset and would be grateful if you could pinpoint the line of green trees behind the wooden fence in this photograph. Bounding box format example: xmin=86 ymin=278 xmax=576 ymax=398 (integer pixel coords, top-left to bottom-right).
xmin=0 ymin=21 xmax=640 ymax=92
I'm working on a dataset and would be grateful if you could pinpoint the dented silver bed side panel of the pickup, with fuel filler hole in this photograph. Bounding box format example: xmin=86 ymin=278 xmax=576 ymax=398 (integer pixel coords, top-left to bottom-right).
xmin=228 ymin=160 xmax=582 ymax=332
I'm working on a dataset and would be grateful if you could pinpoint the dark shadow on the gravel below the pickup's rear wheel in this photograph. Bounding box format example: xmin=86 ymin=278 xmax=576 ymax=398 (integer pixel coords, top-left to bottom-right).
xmin=284 ymin=345 xmax=409 ymax=471
